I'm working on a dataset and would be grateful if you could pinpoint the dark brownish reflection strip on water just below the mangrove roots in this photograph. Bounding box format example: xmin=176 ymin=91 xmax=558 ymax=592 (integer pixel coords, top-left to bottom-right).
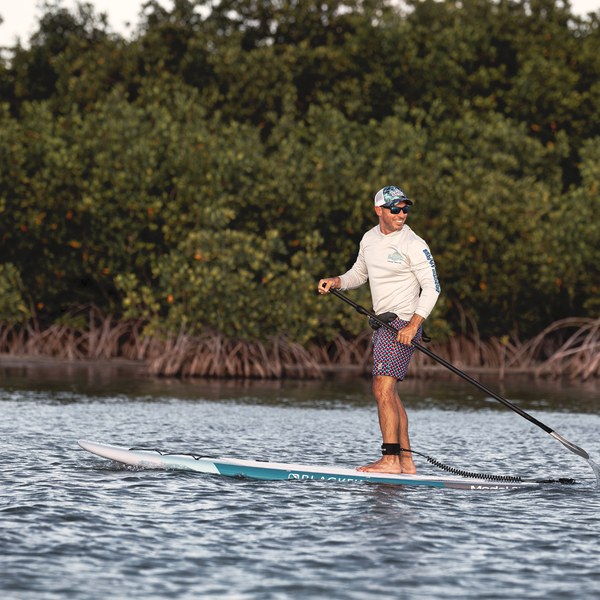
xmin=0 ymin=362 xmax=600 ymax=414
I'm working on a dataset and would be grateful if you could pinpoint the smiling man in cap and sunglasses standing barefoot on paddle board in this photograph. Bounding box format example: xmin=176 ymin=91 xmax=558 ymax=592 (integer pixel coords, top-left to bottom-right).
xmin=318 ymin=186 xmax=440 ymax=473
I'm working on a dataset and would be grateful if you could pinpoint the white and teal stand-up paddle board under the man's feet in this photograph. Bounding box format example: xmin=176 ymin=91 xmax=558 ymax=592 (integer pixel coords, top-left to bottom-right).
xmin=78 ymin=440 xmax=544 ymax=490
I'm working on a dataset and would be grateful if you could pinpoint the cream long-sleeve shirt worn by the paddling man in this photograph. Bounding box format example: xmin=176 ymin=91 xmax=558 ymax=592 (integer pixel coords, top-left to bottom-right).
xmin=340 ymin=225 xmax=440 ymax=321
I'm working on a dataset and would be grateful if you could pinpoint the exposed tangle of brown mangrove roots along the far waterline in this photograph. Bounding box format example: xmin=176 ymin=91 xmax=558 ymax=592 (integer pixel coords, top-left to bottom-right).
xmin=0 ymin=316 xmax=600 ymax=381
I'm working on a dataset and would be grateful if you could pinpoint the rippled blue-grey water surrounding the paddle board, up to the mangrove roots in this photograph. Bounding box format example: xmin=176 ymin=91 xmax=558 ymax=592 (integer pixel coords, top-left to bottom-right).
xmin=0 ymin=368 xmax=600 ymax=600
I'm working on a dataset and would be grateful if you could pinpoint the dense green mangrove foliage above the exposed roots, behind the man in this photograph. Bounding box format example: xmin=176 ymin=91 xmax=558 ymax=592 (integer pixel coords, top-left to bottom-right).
xmin=0 ymin=0 xmax=600 ymax=343
